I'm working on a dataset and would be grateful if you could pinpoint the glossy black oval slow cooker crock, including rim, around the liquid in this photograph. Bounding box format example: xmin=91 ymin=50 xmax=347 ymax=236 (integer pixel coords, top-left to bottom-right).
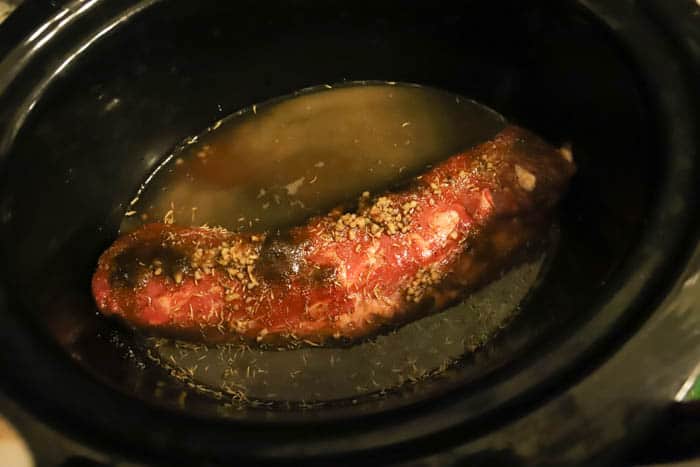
xmin=0 ymin=0 xmax=700 ymax=465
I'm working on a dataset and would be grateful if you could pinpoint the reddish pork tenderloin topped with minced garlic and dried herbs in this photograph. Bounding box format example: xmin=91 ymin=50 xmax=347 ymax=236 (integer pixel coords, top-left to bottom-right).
xmin=92 ymin=126 xmax=575 ymax=346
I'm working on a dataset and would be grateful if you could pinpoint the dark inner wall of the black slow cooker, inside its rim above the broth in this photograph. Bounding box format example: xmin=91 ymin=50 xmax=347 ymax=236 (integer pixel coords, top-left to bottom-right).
xmin=2 ymin=1 xmax=660 ymax=416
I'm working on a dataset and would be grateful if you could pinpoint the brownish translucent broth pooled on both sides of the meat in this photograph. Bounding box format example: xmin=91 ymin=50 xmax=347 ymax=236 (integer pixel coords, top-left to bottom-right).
xmin=121 ymin=83 xmax=543 ymax=405
